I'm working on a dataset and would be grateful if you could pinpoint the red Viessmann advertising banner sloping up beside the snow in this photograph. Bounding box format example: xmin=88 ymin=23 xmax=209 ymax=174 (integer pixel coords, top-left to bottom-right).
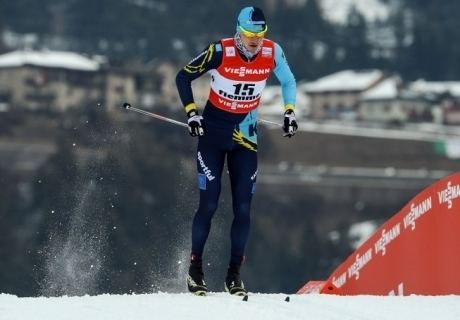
xmin=298 ymin=173 xmax=460 ymax=295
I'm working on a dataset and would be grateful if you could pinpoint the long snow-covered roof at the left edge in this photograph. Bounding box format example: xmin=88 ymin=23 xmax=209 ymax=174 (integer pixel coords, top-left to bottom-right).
xmin=0 ymin=50 xmax=100 ymax=71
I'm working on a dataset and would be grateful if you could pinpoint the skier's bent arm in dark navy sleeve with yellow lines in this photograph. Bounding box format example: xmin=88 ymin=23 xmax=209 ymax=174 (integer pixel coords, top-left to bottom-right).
xmin=176 ymin=42 xmax=222 ymax=114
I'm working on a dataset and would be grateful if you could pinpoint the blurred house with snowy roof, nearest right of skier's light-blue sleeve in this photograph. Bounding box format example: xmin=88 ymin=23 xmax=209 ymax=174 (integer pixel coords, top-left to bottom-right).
xmin=299 ymin=69 xmax=385 ymax=119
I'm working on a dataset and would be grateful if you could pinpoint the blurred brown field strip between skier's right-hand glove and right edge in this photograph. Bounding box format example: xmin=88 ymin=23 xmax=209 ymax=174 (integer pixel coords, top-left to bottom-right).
xmin=259 ymin=127 xmax=460 ymax=171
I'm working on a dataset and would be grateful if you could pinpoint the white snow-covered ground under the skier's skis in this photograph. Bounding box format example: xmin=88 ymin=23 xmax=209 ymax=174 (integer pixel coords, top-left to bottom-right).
xmin=0 ymin=293 xmax=460 ymax=320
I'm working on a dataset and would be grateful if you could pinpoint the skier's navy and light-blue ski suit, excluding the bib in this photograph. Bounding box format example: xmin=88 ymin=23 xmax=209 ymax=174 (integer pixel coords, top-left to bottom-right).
xmin=176 ymin=40 xmax=296 ymax=264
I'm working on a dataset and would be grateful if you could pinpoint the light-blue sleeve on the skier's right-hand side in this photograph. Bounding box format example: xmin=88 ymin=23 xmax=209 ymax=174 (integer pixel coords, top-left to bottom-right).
xmin=273 ymin=43 xmax=296 ymax=106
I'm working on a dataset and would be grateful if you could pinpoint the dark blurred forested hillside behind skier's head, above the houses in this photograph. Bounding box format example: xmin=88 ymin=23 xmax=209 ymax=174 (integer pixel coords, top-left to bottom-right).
xmin=0 ymin=0 xmax=460 ymax=80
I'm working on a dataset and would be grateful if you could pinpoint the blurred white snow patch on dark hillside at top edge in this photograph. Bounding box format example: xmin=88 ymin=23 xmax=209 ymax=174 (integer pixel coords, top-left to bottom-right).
xmin=320 ymin=0 xmax=390 ymax=25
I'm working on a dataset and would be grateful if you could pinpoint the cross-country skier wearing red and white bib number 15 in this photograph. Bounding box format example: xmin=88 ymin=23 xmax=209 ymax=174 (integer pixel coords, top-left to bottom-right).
xmin=176 ymin=7 xmax=297 ymax=295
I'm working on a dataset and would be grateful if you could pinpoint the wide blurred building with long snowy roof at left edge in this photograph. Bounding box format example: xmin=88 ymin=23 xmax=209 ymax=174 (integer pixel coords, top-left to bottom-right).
xmin=0 ymin=50 xmax=135 ymax=111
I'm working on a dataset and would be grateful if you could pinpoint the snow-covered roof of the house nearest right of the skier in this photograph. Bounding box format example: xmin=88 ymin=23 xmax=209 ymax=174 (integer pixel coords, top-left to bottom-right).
xmin=303 ymin=69 xmax=383 ymax=93
